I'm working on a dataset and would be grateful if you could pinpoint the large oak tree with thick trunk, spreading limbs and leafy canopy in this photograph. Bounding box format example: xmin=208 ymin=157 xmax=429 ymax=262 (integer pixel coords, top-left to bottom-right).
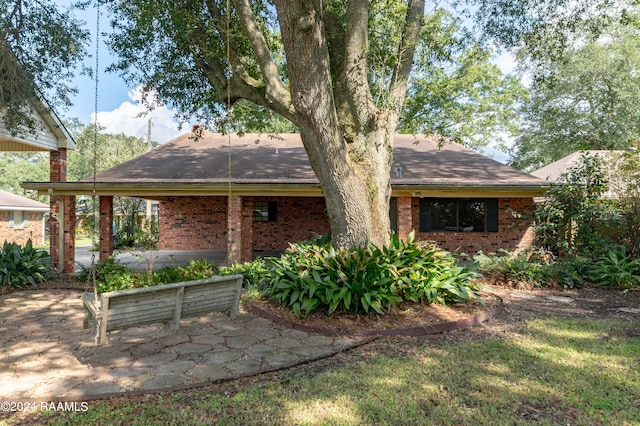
xmin=105 ymin=0 xmax=628 ymax=246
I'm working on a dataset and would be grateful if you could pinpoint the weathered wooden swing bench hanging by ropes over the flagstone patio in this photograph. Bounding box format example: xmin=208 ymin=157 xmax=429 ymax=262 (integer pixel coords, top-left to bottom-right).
xmin=82 ymin=275 xmax=243 ymax=345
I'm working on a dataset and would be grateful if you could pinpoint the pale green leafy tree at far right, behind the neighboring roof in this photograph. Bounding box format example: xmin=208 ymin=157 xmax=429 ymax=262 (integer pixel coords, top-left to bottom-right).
xmin=512 ymin=27 xmax=640 ymax=170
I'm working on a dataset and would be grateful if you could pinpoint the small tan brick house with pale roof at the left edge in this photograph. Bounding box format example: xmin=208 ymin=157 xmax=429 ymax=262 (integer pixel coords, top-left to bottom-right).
xmin=0 ymin=190 xmax=49 ymax=246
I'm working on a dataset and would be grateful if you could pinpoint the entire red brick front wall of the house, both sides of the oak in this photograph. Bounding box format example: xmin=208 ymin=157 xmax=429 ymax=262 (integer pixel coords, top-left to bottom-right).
xmin=159 ymin=197 xmax=533 ymax=258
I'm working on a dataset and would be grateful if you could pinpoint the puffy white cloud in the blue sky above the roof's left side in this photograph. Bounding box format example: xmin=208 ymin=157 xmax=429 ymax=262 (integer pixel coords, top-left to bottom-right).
xmin=91 ymin=87 xmax=186 ymax=143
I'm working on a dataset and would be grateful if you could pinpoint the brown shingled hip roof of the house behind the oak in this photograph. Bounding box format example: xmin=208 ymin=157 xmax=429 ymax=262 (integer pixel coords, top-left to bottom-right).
xmin=25 ymin=133 xmax=548 ymax=195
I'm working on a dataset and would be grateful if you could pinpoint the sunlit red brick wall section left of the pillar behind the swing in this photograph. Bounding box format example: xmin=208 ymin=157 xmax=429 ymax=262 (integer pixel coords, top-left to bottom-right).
xmin=158 ymin=197 xmax=228 ymax=250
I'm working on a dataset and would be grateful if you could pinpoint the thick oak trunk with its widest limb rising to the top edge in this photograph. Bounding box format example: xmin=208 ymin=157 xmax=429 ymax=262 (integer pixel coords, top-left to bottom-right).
xmin=275 ymin=0 xmax=395 ymax=247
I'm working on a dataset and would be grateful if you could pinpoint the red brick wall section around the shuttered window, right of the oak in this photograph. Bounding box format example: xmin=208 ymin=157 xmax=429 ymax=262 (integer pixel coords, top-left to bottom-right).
xmin=412 ymin=198 xmax=533 ymax=255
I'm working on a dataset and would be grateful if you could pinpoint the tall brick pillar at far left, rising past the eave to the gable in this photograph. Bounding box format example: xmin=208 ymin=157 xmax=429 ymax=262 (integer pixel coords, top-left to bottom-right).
xmin=49 ymin=148 xmax=67 ymax=270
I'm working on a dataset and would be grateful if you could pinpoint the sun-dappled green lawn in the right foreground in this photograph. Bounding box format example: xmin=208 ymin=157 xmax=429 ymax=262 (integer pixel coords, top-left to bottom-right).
xmin=7 ymin=318 xmax=640 ymax=425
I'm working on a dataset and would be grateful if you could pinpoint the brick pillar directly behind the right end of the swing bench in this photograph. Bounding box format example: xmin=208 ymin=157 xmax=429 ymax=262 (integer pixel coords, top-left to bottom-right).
xmin=227 ymin=195 xmax=253 ymax=265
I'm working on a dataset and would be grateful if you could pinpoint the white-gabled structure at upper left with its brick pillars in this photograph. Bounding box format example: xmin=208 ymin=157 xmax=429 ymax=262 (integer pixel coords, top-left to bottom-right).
xmin=0 ymin=56 xmax=75 ymax=272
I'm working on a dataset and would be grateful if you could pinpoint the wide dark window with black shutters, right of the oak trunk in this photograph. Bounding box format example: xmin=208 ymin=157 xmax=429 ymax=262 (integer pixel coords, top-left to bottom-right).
xmin=420 ymin=198 xmax=498 ymax=232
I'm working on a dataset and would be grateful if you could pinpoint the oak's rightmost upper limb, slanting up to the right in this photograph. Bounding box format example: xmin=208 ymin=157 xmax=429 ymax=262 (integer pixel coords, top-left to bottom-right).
xmin=389 ymin=0 xmax=425 ymax=117
